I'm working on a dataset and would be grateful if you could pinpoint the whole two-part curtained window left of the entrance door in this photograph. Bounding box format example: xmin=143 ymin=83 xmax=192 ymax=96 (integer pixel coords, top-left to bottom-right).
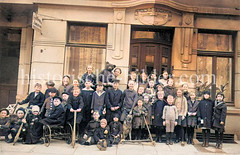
xmin=64 ymin=23 xmax=107 ymax=78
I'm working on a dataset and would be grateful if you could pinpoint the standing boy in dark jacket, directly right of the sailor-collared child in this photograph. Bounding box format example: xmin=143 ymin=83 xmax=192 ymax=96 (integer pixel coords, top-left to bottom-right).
xmin=106 ymin=80 xmax=122 ymax=122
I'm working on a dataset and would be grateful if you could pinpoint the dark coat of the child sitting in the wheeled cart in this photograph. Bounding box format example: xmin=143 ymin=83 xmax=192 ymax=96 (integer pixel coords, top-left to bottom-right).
xmin=40 ymin=104 xmax=65 ymax=125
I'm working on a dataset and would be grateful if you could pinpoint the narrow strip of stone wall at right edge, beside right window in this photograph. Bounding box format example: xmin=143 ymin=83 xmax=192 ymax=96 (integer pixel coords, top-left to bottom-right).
xmin=234 ymin=31 xmax=240 ymax=108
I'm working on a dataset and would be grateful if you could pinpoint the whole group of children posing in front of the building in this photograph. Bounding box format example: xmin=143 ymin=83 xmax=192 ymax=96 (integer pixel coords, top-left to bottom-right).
xmin=0 ymin=69 xmax=226 ymax=150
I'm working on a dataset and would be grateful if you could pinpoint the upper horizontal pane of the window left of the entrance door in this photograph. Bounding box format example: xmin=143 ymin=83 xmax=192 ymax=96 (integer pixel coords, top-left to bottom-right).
xmin=69 ymin=25 xmax=106 ymax=45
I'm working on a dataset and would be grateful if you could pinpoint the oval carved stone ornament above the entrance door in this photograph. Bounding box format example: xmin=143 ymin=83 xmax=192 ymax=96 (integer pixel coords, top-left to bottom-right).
xmin=135 ymin=7 xmax=172 ymax=25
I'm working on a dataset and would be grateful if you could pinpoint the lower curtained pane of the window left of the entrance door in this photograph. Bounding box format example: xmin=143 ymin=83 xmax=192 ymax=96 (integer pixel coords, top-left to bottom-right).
xmin=65 ymin=47 xmax=106 ymax=79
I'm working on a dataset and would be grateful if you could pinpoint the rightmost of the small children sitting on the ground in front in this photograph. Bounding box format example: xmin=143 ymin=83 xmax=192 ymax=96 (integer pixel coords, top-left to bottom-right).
xmin=109 ymin=113 xmax=123 ymax=144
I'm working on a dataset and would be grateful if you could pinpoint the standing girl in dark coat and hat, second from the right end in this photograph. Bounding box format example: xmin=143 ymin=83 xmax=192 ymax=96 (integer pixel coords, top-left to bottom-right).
xmin=198 ymin=91 xmax=213 ymax=147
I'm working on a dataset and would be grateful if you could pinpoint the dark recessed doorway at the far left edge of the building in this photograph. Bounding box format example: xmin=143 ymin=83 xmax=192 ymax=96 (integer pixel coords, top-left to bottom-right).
xmin=0 ymin=27 xmax=21 ymax=107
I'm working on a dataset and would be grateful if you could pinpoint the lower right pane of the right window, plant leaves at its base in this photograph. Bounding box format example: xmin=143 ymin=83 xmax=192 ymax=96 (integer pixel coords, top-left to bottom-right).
xmin=216 ymin=58 xmax=232 ymax=102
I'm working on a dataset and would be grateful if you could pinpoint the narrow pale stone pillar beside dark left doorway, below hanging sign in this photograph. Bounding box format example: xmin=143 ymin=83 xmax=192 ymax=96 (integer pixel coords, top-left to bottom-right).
xmin=16 ymin=27 xmax=33 ymax=101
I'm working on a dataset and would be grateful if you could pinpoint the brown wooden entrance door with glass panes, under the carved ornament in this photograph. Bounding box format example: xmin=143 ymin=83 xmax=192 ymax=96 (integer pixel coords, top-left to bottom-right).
xmin=129 ymin=26 xmax=174 ymax=74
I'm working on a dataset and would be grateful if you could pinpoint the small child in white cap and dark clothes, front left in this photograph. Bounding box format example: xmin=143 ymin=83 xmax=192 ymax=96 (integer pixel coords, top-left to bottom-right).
xmin=25 ymin=105 xmax=43 ymax=144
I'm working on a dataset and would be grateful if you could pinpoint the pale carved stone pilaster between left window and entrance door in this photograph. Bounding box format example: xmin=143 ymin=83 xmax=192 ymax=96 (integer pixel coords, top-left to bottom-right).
xmin=106 ymin=9 xmax=131 ymax=90
